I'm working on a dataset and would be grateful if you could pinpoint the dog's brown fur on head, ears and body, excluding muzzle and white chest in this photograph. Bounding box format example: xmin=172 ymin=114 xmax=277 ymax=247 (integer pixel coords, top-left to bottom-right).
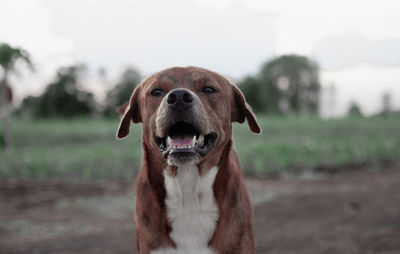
xmin=117 ymin=67 xmax=261 ymax=254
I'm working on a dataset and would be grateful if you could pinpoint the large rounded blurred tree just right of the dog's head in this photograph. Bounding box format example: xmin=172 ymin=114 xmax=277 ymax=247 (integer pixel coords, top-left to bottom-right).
xmin=239 ymin=55 xmax=321 ymax=114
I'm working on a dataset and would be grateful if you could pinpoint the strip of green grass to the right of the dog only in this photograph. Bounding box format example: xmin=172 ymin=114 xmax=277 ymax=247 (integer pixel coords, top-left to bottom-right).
xmin=235 ymin=117 xmax=400 ymax=175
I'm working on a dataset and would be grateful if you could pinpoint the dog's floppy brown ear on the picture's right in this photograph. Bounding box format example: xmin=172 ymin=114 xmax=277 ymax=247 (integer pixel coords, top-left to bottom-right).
xmin=231 ymin=84 xmax=261 ymax=133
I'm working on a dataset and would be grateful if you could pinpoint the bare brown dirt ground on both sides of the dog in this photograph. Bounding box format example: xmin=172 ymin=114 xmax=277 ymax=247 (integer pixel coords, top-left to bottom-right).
xmin=0 ymin=167 xmax=400 ymax=254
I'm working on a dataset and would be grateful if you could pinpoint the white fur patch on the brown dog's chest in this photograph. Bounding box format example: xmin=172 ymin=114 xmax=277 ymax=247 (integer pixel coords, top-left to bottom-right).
xmin=153 ymin=165 xmax=218 ymax=254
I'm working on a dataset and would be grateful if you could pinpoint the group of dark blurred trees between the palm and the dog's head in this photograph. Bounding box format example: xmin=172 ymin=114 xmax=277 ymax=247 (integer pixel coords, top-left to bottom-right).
xmin=16 ymin=65 xmax=141 ymax=118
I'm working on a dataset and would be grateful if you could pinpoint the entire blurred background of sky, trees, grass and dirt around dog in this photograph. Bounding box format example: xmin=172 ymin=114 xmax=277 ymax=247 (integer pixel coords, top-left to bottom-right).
xmin=0 ymin=0 xmax=400 ymax=253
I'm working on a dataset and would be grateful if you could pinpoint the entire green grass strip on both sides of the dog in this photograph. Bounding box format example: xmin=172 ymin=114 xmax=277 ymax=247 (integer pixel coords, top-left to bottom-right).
xmin=0 ymin=117 xmax=400 ymax=182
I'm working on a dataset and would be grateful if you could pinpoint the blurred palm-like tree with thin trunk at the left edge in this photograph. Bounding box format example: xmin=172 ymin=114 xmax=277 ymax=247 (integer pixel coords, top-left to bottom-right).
xmin=0 ymin=43 xmax=33 ymax=152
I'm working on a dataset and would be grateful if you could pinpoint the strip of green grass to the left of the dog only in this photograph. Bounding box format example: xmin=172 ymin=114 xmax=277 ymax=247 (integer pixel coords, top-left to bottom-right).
xmin=0 ymin=119 xmax=141 ymax=181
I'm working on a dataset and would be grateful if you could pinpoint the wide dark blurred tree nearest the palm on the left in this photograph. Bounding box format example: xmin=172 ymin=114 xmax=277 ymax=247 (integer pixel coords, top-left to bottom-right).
xmin=21 ymin=65 xmax=96 ymax=117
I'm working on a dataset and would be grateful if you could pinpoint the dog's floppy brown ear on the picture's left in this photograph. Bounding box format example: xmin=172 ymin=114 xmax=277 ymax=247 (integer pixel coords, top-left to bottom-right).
xmin=117 ymin=87 xmax=142 ymax=139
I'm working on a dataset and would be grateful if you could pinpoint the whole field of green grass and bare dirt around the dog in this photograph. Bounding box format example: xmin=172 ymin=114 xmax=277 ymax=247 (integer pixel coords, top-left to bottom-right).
xmin=0 ymin=117 xmax=400 ymax=254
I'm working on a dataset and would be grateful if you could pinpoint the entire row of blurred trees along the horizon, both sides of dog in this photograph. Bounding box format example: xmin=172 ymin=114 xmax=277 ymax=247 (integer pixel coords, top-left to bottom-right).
xmin=0 ymin=43 xmax=398 ymax=152
